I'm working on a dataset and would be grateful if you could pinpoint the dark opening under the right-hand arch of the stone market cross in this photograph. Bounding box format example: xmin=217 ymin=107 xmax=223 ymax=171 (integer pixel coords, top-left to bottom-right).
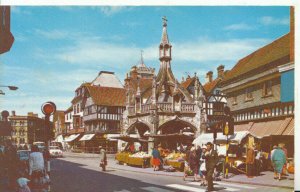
xmin=157 ymin=117 xmax=198 ymax=133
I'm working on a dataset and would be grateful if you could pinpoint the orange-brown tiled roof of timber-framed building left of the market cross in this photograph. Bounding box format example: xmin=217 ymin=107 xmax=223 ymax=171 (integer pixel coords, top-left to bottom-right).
xmin=87 ymin=86 xmax=126 ymax=106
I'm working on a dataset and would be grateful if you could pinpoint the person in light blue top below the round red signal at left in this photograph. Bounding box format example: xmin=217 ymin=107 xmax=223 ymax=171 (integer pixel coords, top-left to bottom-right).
xmin=29 ymin=145 xmax=46 ymax=192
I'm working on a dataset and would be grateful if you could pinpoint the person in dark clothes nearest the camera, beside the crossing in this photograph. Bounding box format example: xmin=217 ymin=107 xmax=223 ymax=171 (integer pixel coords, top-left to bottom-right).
xmin=203 ymin=142 xmax=218 ymax=191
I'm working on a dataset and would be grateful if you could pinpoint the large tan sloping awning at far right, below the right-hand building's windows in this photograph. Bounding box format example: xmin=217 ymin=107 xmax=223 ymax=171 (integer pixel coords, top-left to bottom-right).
xmin=250 ymin=117 xmax=292 ymax=138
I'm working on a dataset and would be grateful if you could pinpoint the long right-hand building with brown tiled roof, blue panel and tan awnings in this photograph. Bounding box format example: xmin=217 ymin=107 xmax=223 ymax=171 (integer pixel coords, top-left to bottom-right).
xmin=220 ymin=30 xmax=294 ymax=156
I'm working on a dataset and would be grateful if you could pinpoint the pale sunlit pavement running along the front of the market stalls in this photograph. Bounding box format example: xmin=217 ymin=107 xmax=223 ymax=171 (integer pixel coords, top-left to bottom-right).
xmin=65 ymin=152 xmax=294 ymax=189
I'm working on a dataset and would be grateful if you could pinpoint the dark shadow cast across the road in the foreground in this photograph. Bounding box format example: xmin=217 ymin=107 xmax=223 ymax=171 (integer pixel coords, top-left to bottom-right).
xmin=51 ymin=159 xmax=179 ymax=192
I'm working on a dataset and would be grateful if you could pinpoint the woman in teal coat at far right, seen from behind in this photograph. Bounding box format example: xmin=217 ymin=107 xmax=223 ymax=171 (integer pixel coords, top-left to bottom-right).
xmin=272 ymin=146 xmax=286 ymax=181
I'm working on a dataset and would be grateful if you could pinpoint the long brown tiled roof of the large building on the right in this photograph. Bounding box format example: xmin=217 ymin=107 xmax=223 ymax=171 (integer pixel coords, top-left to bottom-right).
xmin=224 ymin=33 xmax=290 ymax=81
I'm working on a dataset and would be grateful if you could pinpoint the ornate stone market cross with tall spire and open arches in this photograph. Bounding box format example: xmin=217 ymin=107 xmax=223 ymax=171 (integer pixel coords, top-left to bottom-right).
xmin=122 ymin=19 xmax=203 ymax=151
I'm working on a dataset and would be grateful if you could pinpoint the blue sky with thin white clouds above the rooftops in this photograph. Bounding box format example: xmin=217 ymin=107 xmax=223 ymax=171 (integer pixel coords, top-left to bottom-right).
xmin=0 ymin=6 xmax=289 ymax=115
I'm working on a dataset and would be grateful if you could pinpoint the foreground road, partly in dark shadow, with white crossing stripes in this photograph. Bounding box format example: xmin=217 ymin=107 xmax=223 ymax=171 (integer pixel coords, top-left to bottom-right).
xmin=51 ymin=157 xmax=291 ymax=192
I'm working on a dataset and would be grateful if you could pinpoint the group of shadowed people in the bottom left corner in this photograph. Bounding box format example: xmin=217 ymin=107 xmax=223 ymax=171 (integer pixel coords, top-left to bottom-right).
xmin=0 ymin=140 xmax=50 ymax=192
